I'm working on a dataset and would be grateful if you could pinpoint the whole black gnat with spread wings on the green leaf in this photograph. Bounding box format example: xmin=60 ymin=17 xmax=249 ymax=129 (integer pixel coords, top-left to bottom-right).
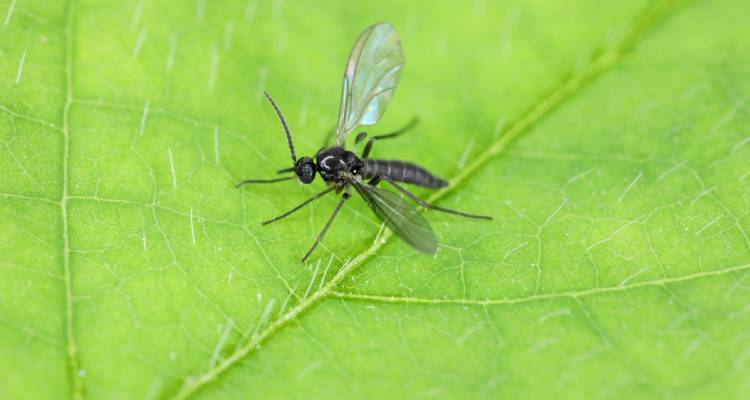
xmin=237 ymin=22 xmax=492 ymax=262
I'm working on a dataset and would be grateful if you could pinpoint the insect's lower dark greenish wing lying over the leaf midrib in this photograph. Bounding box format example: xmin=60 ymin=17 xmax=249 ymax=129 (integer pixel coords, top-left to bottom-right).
xmin=352 ymin=181 xmax=437 ymax=254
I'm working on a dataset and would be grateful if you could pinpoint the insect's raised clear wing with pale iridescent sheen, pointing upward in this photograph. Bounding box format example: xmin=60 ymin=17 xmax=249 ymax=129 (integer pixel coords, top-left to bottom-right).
xmin=336 ymin=22 xmax=404 ymax=146
